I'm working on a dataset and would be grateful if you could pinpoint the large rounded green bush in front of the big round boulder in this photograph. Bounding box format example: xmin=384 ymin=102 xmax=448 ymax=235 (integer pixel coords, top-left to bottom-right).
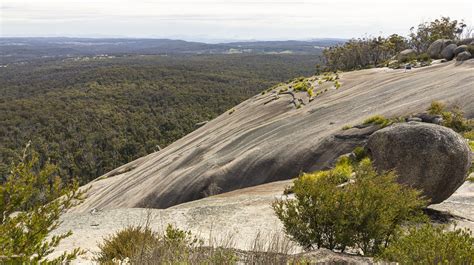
xmin=273 ymin=157 xmax=427 ymax=255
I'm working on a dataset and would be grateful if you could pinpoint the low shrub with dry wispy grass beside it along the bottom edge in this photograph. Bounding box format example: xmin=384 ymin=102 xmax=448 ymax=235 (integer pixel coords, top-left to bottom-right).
xmin=96 ymin=211 xmax=308 ymax=264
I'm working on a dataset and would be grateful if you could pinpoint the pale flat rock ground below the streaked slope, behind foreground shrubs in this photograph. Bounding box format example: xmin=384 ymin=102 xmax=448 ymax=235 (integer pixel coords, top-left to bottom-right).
xmin=53 ymin=174 xmax=474 ymax=264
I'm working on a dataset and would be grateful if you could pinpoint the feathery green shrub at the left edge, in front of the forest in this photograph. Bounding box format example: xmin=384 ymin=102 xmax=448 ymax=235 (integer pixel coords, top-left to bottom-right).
xmin=0 ymin=144 xmax=84 ymax=264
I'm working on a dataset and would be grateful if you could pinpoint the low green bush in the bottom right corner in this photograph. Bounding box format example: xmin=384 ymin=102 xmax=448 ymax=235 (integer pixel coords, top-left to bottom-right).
xmin=379 ymin=224 xmax=474 ymax=264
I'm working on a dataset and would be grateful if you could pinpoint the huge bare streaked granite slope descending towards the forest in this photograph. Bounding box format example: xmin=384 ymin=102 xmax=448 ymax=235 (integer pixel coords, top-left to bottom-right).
xmin=74 ymin=60 xmax=474 ymax=212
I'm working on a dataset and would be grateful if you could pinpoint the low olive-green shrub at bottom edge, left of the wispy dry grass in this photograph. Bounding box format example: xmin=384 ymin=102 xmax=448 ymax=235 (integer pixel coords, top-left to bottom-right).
xmin=98 ymin=225 xmax=237 ymax=264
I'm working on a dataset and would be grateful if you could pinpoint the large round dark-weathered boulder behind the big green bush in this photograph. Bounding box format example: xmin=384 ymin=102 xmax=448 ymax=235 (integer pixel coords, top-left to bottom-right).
xmin=367 ymin=122 xmax=472 ymax=204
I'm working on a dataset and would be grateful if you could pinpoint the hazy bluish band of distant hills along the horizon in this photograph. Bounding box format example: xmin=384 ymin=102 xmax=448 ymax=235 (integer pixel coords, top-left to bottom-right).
xmin=0 ymin=38 xmax=343 ymax=65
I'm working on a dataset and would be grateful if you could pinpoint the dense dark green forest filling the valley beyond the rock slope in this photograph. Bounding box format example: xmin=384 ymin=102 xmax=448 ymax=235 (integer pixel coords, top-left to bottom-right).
xmin=0 ymin=55 xmax=318 ymax=183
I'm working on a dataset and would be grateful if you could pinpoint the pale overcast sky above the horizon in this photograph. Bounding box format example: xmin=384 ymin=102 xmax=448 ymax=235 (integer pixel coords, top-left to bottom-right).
xmin=0 ymin=0 xmax=474 ymax=42
